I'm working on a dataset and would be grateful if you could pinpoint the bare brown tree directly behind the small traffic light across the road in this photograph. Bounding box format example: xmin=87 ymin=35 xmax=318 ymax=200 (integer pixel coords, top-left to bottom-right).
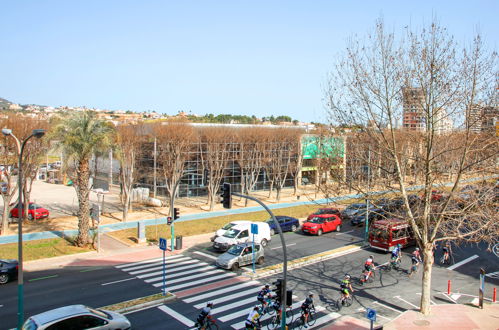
xmin=153 ymin=122 xmax=196 ymax=211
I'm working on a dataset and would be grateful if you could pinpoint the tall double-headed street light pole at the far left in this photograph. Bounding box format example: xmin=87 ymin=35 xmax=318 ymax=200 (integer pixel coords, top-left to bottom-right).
xmin=2 ymin=128 xmax=45 ymax=329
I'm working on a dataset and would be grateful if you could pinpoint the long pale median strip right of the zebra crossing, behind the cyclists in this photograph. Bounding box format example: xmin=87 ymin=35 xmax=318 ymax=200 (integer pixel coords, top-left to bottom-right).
xmin=242 ymin=244 xmax=362 ymax=279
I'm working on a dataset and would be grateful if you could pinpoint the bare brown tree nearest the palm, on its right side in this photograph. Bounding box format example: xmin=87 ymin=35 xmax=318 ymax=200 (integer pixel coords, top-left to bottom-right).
xmin=116 ymin=124 xmax=144 ymax=221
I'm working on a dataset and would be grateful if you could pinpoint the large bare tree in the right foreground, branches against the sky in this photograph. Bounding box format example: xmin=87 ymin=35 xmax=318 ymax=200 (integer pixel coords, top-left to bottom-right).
xmin=325 ymin=22 xmax=499 ymax=314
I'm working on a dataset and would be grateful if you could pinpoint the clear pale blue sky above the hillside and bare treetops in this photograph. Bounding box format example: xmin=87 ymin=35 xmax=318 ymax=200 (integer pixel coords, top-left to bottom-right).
xmin=0 ymin=0 xmax=499 ymax=122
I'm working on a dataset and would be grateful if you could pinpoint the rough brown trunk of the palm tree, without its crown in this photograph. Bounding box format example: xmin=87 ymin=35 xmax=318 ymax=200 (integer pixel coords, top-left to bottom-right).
xmin=75 ymin=160 xmax=90 ymax=246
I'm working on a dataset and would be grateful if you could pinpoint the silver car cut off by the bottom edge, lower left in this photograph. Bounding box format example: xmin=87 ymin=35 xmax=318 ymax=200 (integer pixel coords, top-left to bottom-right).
xmin=22 ymin=305 xmax=131 ymax=330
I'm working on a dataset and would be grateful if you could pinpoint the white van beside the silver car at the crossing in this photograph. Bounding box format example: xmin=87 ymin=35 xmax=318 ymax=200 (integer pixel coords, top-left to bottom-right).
xmin=213 ymin=222 xmax=271 ymax=251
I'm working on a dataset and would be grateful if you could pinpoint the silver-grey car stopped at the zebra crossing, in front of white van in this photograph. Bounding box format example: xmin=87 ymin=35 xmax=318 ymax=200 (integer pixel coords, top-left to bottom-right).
xmin=215 ymin=243 xmax=265 ymax=270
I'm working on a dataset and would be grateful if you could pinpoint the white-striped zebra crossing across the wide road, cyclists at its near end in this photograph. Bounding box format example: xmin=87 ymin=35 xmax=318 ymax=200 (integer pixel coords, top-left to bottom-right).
xmin=115 ymin=255 xmax=340 ymax=329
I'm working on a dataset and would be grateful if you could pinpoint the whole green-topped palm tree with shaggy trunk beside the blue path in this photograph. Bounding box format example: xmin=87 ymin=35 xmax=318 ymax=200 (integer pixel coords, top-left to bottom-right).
xmin=52 ymin=110 xmax=113 ymax=246
